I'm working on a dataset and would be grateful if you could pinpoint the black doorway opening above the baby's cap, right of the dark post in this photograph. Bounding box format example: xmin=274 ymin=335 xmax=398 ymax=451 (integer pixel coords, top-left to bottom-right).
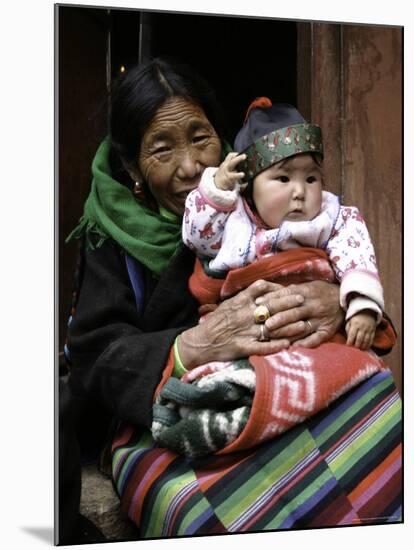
xmin=144 ymin=13 xmax=296 ymax=137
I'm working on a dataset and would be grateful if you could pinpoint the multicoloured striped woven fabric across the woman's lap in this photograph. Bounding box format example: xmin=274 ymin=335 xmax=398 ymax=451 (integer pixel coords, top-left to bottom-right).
xmin=113 ymin=371 xmax=402 ymax=538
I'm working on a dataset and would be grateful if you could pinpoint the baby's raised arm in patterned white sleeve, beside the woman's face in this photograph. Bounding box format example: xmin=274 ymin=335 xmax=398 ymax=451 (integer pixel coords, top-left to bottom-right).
xmin=182 ymin=153 xmax=245 ymax=258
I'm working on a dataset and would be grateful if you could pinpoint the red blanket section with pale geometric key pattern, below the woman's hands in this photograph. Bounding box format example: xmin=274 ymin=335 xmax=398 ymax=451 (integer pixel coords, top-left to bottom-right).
xmin=221 ymin=343 xmax=386 ymax=453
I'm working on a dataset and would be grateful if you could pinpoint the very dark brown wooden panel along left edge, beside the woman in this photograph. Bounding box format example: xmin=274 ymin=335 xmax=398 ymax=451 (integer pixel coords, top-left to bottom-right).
xmin=57 ymin=6 xmax=108 ymax=362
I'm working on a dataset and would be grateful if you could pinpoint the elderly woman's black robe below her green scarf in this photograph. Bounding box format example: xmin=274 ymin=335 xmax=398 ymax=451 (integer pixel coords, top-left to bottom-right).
xmin=58 ymin=240 xmax=198 ymax=544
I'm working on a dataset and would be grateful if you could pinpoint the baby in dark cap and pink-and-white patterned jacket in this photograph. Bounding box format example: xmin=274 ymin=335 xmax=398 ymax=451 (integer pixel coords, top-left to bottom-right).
xmin=183 ymin=98 xmax=384 ymax=350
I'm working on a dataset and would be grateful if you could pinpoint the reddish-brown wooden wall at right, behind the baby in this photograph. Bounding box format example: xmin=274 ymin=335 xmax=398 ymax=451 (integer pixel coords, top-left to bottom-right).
xmin=298 ymin=23 xmax=402 ymax=391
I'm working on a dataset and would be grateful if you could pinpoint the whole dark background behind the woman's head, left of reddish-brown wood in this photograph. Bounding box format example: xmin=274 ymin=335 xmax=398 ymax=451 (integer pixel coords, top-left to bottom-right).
xmin=56 ymin=6 xmax=297 ymax=367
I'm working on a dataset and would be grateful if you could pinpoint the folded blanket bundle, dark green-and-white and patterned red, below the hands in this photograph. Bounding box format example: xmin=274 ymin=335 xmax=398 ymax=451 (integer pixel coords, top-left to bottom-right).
xmin=152 ymin=343 xmax=385 ymax=458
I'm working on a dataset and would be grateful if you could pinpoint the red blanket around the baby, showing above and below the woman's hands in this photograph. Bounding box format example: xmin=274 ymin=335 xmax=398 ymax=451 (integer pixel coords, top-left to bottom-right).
xmin=154 ymin=248 xmax=396 ymax=454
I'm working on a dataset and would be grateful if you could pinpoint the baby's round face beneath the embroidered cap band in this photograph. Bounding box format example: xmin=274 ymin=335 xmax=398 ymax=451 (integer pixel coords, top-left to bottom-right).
xmin=253 ymin=153 xmax=322 ymax=228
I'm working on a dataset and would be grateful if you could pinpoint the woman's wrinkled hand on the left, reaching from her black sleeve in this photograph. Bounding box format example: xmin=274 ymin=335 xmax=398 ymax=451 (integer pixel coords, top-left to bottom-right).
xmin=178 ymin=280 xmax=304 ymax=370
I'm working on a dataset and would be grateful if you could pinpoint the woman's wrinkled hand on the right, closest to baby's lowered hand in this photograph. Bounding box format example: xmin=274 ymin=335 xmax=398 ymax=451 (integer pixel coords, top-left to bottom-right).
xmin=256 ymin=281 xmax=344 ymax=348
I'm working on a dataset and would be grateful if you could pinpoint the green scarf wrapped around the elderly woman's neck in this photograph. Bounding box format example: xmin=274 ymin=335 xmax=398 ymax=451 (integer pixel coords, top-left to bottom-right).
xmin=66 ymin=137 xmax=230 ymax=275
